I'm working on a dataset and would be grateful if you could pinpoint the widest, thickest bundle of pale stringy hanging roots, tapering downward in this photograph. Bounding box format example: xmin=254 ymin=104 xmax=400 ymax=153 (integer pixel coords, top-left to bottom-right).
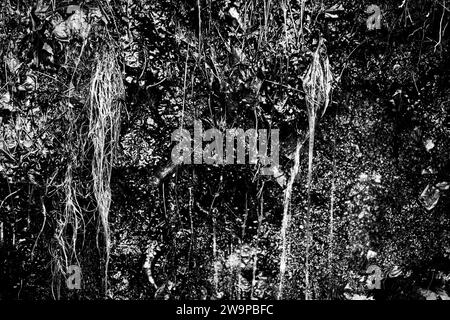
xmin=89 ymin=49 xmax=125 ymax=293
